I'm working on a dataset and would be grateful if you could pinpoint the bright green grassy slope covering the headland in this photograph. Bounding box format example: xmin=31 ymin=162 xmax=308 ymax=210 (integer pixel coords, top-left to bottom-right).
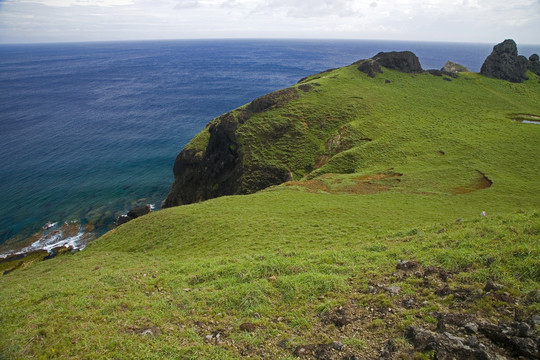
xmin=0 ymin=63 xmax=540 ymax=359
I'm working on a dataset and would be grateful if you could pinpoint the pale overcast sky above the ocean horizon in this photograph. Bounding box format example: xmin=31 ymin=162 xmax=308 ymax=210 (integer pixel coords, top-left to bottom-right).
xmin=0 ymin=0 xmax=540 ymax=44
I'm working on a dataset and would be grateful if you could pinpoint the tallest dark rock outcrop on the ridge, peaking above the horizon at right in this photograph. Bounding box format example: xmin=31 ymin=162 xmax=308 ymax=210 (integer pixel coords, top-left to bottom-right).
xmin=480 ymin=39 xmax=528 ymax=83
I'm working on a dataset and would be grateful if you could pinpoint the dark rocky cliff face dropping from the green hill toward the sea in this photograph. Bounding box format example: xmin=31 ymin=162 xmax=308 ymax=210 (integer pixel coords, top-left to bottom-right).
xmin=163 ymin=88 xmax=298 ymax=208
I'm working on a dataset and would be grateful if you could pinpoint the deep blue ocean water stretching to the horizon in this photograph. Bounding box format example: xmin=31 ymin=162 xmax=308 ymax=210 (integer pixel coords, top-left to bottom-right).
xmin=0 ymin=40 xmax=540 ymax=253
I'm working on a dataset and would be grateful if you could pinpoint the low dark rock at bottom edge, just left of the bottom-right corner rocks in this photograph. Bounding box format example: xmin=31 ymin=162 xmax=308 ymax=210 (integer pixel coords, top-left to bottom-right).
xmin=405 ymin=326 xmax=492 ymax=360
